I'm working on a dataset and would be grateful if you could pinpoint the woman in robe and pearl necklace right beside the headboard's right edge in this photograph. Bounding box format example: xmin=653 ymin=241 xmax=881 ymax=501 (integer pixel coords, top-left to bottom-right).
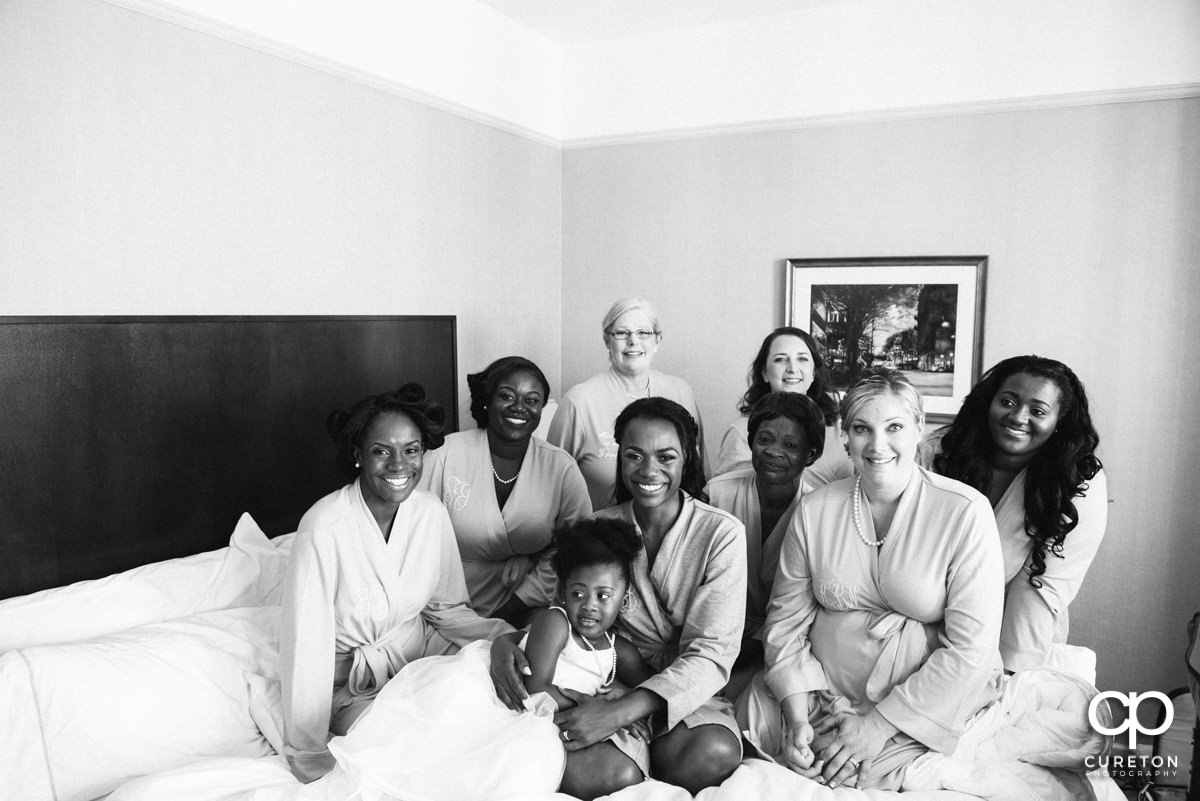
xmin=420 ymin=356 xmax=592 ymax=626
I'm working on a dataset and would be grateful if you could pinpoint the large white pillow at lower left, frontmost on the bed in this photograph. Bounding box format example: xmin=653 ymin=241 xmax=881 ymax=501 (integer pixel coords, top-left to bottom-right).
xmin=0 ymin=607 xmax=280 ymax=801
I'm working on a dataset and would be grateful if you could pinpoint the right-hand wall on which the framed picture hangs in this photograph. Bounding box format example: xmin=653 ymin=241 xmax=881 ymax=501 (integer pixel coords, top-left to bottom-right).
xmin=562 ymin=100 xmax=1200 ymax=691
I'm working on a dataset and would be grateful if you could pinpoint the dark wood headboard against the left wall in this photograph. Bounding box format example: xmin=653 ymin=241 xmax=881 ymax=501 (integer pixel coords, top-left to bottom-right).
xmin=0 ymin=317 xmax=457 ymax=597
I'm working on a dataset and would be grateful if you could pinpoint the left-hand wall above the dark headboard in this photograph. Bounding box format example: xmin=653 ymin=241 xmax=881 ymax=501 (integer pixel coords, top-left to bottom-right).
xmin=0 ymin=0 xmax=562 ymax=427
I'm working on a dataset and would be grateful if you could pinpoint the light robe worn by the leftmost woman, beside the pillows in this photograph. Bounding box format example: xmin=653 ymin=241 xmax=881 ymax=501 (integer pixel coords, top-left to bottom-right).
xmin=280 ymin=481 xmax=512 ymax=781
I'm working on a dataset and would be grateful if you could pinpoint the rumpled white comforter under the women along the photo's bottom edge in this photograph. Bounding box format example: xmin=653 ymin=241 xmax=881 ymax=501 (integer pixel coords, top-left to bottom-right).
xmin=108 ymin=670 xmax=1122 ymax=801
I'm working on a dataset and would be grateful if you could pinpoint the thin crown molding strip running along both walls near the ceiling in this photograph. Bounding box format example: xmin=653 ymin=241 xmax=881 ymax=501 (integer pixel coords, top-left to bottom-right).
xmin=102 ymin=0 xmax=1200 ymax=150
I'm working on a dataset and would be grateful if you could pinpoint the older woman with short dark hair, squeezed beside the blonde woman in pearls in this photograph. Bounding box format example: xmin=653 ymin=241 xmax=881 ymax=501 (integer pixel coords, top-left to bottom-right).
xmin=707 ymin=392 xmax=826 ymax=676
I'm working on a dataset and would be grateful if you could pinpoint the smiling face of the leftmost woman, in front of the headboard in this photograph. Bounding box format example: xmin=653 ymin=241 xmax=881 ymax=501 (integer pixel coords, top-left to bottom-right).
xmin=354 ymin=412 xmax=425 ymax=520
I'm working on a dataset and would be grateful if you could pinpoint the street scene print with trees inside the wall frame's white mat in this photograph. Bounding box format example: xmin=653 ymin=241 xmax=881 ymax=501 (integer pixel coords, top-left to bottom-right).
xmin=808 ymin=284 xmax=959 ymax=397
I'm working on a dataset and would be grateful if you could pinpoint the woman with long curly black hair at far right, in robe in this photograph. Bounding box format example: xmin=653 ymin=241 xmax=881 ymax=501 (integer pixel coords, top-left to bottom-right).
xmin=918 ymin=356 xmax=1108 ymax=671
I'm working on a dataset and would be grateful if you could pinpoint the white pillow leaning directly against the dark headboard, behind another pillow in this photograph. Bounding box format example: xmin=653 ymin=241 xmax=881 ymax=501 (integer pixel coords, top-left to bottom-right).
xmin=0 ymin=514 xmax=290 ymax=654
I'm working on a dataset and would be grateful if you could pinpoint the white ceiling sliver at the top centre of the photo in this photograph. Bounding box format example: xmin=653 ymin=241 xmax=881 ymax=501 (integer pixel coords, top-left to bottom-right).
xmin=479 ymin=0 xmax=853 ymax=44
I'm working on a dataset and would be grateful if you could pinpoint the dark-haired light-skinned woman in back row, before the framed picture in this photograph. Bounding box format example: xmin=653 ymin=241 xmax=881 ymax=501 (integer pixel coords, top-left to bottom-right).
xmin=714 ymin=325 xmax=853 ymax=488
